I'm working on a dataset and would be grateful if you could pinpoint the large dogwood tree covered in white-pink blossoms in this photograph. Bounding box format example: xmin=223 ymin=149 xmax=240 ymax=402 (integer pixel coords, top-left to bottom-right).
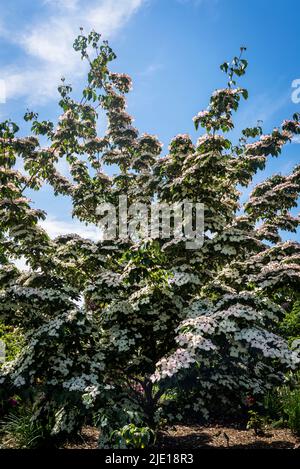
xmin=0 ymin=31 xmax=300 ymax=445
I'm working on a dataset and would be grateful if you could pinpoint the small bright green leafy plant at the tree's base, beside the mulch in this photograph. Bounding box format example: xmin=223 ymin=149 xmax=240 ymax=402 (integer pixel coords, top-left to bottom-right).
xmin=111 ymin=423 xmax=155 ymax=449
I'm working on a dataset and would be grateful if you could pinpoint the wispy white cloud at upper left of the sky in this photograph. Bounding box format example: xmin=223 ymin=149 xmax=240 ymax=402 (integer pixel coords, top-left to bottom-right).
xmin=0 ymin=0 xmax=145 ymax=104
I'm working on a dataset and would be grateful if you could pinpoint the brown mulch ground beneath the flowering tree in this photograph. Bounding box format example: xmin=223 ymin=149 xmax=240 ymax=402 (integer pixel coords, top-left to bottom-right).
xmin=64 ymin=425 xmax=300 ymax=451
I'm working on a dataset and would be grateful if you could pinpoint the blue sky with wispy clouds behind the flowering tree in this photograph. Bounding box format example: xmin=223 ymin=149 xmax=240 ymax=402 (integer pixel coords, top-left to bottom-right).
xmin=0 ymin=0 xmax=300 ymax=239
